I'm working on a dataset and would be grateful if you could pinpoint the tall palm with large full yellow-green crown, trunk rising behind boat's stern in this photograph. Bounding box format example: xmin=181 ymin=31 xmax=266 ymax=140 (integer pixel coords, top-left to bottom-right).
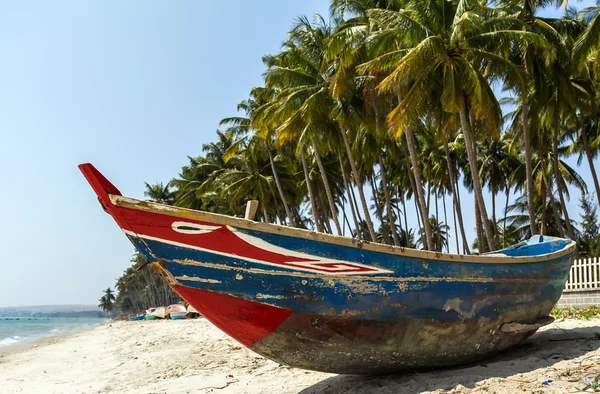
xmin=360 ymin=0 xmax=527 ymax=249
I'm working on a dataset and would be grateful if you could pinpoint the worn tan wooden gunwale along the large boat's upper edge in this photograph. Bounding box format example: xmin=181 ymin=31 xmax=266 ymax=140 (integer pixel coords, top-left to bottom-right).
xmin=108 ymin=194 xmax=576 ymax=264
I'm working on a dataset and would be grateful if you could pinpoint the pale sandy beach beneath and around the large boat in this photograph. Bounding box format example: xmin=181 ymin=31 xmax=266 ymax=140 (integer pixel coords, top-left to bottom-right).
xmin=0 ymin=319 xmax=600 ymax=394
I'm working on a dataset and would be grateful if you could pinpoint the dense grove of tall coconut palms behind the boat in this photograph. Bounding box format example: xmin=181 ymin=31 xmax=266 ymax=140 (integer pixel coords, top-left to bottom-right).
xmin=146 ymin=0 xmax=600 ymax=254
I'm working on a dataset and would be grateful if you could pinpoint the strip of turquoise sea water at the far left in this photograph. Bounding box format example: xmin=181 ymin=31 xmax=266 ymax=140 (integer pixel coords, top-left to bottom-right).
xmin=0 ymin=317 xmax=108 ymax=349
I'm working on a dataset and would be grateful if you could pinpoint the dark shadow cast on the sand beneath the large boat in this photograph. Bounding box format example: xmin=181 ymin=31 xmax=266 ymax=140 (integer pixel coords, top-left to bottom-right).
xmin=300 ymin=321 xmax=600 ymax=394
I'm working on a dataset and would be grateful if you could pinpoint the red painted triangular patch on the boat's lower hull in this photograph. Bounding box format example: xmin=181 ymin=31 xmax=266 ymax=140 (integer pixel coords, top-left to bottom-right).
xmin=172 ymin=285 xmax=292 ymax=346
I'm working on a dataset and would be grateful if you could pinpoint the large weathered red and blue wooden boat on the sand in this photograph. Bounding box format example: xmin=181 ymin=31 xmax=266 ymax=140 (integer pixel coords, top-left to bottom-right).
xmin=80 ymin=164 xmax=575 ymax=374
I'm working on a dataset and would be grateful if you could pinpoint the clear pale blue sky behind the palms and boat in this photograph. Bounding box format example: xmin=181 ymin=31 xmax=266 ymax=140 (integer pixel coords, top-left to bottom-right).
xmin=0 ymin=0 xmax=592 ymax=306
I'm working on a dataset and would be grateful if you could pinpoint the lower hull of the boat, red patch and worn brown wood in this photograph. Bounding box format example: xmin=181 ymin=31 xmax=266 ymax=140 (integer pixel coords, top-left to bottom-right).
xmin=174 ymin=286 xmax=549 ymax=374
